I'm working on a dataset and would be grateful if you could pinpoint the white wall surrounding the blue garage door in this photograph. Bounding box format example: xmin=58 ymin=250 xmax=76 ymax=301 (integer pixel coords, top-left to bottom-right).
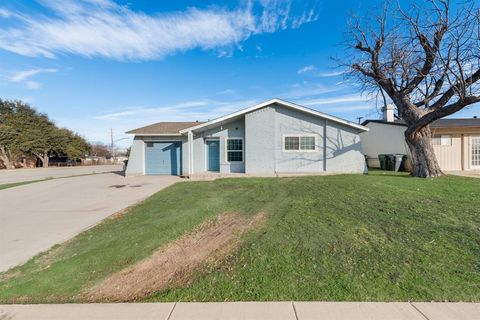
xmin=125 ymin=136 xmax=188 ymax=176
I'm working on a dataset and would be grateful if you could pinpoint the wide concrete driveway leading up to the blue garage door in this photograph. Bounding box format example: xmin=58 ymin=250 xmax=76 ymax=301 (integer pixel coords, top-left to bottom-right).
xmin=0 ymin=173 xmax=180 ymax=271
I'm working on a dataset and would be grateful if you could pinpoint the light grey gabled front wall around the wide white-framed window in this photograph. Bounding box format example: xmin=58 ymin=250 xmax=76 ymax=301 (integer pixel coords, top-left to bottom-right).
xmin=245 ymin=105 xmax=366 ymax=174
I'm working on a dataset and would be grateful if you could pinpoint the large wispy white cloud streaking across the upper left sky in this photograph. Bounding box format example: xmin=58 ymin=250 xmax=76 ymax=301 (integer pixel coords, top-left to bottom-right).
xmin=0 ymin=0 xmax=318 ymax=60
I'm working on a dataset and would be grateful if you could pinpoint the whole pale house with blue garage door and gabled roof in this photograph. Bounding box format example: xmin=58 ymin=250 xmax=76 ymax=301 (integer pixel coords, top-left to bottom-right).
xmin=126 ymin=99 xmax=368 ymax=175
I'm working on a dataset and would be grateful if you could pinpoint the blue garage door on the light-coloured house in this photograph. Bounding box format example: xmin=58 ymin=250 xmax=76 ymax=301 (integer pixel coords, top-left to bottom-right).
xmin=145 ymin=142 xmax=182 ymax=175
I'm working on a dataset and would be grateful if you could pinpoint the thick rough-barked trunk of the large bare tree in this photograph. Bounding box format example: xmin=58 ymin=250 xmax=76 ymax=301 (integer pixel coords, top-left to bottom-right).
xmin=405 ymin=126 xmax=443 ymax=178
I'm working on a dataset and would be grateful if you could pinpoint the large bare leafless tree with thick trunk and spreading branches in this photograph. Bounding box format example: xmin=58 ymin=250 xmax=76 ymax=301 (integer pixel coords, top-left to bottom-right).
xmin=346 ymin=0 xmax=480 ymax=177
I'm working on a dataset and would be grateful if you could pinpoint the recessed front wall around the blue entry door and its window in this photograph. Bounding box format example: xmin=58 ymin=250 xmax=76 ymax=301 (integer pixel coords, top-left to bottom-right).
xmin=191 ymin=118 xmax=246 ymax=173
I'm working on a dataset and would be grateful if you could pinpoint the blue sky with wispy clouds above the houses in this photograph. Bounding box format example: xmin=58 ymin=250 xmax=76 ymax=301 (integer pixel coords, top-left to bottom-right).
xmin=0 ymin=0 xmax=479 ymax=146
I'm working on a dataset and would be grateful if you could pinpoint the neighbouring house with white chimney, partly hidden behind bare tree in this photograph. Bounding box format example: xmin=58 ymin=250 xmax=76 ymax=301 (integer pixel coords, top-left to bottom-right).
xmin=360 ymin=105 xmax=480 ymax=171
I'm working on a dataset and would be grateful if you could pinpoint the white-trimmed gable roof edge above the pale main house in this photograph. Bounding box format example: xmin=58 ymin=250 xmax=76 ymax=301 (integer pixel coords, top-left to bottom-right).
xmin=180 ymin=98 xmax=369 ymax=133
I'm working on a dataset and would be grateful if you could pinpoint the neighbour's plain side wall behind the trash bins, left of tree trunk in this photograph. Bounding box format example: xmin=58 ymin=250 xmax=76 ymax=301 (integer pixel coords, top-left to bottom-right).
xmin=360 ymin=122 xmax=409 ymax=168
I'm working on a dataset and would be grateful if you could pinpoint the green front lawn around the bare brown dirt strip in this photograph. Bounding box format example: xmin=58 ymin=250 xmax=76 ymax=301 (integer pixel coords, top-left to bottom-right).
xmin=0 ymin=172 xmax=480 ymax=303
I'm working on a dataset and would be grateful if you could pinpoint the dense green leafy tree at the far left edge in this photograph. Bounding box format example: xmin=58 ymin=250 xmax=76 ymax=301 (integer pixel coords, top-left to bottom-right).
xmin=0 ymin=100 xmax=90 ymax=168
